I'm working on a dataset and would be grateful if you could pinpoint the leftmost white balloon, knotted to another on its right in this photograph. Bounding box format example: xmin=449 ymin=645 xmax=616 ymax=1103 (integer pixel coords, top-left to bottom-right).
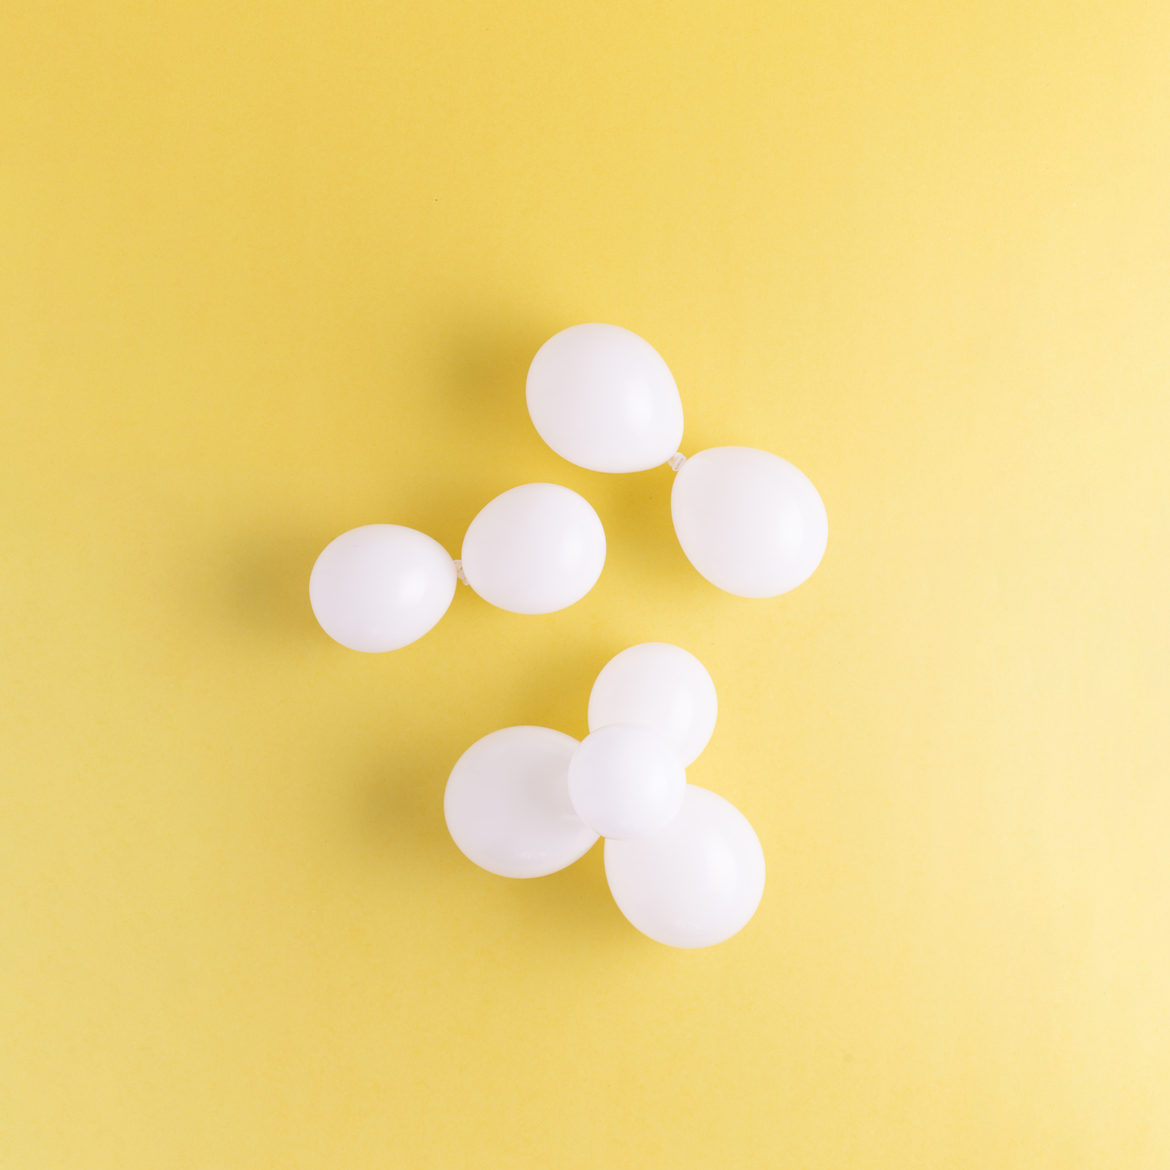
xmin=309 ymin=524 xmax=456 ymax=653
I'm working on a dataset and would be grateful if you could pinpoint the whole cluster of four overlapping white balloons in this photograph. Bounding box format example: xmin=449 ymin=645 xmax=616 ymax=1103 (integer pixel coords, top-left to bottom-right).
xmin=443 ymin=642 xmax=764 ymax=947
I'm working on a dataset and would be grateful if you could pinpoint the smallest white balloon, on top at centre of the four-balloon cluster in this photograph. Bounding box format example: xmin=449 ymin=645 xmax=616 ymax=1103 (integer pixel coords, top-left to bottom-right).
xmin=569 ymin=723 xmax=687 ymax=839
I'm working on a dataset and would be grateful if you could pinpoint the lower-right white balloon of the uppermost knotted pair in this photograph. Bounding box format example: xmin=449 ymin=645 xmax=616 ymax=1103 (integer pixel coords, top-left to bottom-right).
xmin=670 ymin=447 xmax=828 ymax=597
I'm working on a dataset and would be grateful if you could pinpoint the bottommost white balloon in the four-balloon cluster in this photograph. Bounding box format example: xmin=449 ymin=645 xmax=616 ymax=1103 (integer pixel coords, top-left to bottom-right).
xmin=605 ymin=784 xmax=764 ymax=947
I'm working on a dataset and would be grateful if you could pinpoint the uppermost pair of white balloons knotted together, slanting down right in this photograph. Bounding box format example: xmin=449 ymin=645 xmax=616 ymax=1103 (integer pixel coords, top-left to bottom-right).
xmin=527 ymin=324 xmax=828 ymax=597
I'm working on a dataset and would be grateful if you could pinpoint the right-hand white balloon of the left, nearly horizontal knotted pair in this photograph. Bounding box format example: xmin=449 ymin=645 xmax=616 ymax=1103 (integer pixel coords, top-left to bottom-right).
xmin=461 ymin=483 xmax=605 ymax=613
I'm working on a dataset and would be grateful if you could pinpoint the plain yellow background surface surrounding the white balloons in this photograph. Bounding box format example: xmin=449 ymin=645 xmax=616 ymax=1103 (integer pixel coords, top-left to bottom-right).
xmin=0 ymin=0 xmax=1170 ymax=1170
